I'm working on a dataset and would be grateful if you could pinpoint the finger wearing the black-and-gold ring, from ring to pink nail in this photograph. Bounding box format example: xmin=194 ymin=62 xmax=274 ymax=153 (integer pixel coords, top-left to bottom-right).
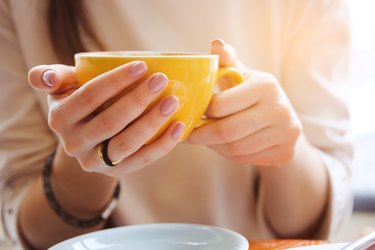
xmin=108 ymin=96 xmax=179 ymax=159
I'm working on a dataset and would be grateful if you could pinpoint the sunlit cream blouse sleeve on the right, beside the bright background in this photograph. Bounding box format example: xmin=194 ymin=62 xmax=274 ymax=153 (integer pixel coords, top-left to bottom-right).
xmin=280 ymin=0 xmax=353 ymax=237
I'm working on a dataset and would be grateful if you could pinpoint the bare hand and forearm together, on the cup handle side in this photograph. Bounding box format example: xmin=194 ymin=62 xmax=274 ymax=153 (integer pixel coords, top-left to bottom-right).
xmin=187 ymin=40 xmax=329 ymax=238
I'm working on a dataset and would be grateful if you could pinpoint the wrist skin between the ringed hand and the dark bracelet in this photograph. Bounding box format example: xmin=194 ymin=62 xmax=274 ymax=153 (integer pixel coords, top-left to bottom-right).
xmin=50 ymin=147 xmax=118 ymax=219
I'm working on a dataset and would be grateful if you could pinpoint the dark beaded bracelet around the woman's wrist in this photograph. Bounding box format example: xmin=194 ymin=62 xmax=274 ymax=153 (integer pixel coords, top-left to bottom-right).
xmin=43 ymin=153 xmax=120 ymax=228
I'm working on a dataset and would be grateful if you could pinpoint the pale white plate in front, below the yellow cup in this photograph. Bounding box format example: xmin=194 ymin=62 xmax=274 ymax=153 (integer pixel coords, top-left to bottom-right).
xmin=49 ymin=223 xmax=248 ymax=250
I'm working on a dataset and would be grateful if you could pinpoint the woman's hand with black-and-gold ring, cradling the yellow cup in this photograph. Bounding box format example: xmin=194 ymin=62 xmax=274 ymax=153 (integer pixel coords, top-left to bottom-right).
xmin=29 ymin=61 xmax=184 ymax=177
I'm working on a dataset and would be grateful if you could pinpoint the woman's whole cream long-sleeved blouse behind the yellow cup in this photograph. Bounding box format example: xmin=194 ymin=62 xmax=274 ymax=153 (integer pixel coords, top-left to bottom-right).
xmin=0 ymin=0 xmax=352 ymax=249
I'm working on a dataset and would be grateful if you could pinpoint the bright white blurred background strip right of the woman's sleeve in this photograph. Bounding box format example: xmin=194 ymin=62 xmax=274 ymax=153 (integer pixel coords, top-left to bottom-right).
xmin=335 ymin=0 xmax=375 ymax=240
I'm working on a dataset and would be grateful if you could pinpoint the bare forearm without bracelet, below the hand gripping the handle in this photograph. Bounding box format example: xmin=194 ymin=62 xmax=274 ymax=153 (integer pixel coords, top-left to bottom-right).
xmin=260 ymin=137 xmax=329 ymax=237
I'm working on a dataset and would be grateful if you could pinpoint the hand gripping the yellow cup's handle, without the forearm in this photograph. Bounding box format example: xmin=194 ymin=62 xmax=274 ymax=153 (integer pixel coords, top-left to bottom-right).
xmin=186 ymin=40 xmax=302 ymax=166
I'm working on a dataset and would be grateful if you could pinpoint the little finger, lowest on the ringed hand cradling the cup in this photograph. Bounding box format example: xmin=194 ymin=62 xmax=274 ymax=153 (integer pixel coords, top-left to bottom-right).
xmin=106 ymin=121 xmax=185 ymax=176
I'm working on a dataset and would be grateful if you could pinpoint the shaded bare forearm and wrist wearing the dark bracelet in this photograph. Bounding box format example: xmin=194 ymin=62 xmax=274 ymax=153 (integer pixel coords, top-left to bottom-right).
xmin=19 ymin=146 xmax=116 ymax=249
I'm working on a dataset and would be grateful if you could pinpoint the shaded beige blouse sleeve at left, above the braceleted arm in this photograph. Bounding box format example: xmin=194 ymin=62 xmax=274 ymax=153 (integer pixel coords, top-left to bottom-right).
xmin=0 ymin=1 xmax=56 ymax=249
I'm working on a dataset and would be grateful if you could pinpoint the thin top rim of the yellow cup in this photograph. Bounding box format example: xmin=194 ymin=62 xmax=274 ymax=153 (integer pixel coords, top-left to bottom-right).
xmin=74 ymin=50 xmax=218 ymax=58
